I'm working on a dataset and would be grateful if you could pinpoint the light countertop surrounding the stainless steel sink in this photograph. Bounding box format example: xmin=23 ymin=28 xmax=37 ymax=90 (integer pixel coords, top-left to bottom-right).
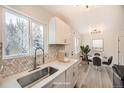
xmin=0 ymin=59 xmax=78 ymax=88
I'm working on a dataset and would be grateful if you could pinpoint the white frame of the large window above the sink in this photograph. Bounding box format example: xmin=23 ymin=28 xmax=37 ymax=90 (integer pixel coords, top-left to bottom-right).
xmin=2 ymin=8 xmax=48 ymax=59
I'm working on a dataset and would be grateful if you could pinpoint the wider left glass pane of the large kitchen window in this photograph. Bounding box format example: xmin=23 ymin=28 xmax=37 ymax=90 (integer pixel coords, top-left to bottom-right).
xmin=4 ymin=12 xmax=29 ymax=57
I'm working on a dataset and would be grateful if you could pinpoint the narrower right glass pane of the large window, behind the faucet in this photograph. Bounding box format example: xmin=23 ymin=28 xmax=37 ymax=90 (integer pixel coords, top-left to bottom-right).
xmin=31 ymin=22 xmax=44 ymax=53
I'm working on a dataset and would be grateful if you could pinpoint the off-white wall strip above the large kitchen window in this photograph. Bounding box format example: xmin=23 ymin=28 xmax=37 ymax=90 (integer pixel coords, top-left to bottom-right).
xmin=9 ymin=5 xmax=52 ymax=24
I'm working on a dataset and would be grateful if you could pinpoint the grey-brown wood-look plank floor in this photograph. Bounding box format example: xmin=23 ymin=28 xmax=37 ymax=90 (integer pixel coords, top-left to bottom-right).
xmin=77 ymin=64 xmax=113 ymax=88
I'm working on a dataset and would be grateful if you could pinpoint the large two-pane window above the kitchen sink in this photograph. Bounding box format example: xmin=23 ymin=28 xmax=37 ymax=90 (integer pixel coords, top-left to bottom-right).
xmin=3 ymin=10 xmax=48 ymax=59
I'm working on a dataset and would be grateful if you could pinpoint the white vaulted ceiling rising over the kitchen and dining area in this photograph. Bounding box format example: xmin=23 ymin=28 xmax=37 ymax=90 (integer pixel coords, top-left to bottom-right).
xmin=41 ymin=5 xmax=122 ymax=33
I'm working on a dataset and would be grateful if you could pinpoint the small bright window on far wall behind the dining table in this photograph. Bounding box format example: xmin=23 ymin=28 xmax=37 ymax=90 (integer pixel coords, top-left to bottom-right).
xmin=93 ymin=39 xmax=103 ymax=51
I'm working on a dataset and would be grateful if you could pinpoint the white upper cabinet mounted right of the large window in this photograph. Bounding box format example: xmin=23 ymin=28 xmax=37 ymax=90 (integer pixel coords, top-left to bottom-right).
xmin=49 ymin=17 xmax=71 ymax=44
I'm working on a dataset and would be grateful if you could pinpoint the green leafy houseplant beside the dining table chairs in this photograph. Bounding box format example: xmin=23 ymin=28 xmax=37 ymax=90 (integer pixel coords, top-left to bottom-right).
xmin=80 ymin=45 xmax=91 ymax=61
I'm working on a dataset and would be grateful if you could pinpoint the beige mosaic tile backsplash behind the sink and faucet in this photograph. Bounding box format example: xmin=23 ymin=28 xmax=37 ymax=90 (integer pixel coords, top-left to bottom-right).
xmin=0 ymin=45 xmax=64 ymax=77
